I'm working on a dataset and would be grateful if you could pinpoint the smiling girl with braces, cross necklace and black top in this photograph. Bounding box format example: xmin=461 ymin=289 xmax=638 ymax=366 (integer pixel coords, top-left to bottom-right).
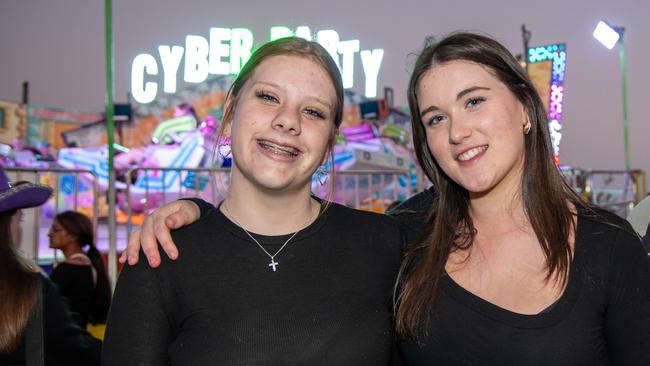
xmin=102 ymin=37 xmax=402 ymax=366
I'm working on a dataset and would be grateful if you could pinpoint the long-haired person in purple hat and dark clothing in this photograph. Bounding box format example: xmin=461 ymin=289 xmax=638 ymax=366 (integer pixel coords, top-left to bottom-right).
xmin=0 ymin=168 xmax=101 ymax=366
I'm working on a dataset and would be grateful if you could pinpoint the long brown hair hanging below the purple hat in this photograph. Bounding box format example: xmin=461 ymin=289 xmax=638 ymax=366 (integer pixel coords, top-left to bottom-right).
xmin=0 ymin=210 xmax=38 ymax=354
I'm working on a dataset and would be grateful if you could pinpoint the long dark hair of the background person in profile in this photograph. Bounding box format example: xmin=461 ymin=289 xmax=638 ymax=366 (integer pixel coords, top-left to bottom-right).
xmin=54 ymin=211 xmax=111 ymax=324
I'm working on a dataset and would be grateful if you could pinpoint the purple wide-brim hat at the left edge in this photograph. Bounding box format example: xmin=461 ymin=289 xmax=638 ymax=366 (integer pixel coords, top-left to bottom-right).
xmin=0 ymin=169 xmax=52 ymax=212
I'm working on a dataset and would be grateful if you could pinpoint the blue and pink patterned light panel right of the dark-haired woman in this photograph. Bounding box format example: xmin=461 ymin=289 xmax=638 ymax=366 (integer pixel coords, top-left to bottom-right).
xmin=528 ymin=43 xmax=566 ymax=165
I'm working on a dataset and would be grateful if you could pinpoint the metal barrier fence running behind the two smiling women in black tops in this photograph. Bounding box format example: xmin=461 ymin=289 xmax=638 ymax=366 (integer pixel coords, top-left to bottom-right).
xmin=10 ymin=167 xmax=648 ymax=283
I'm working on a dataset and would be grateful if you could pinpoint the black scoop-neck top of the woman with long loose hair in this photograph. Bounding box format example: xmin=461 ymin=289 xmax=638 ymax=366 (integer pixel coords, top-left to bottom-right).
xmin=393 ymin=191 xmax=650 ymax=366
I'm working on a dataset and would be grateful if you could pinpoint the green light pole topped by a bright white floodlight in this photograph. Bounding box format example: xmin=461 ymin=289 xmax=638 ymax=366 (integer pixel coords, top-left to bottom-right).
xmin=594 ymin=20 xmax=632 ymax=171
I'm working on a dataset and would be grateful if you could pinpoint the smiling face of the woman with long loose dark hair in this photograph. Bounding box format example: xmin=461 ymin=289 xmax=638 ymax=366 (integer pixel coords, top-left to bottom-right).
xmin=417 ymin=61 xmax=526 ymax=195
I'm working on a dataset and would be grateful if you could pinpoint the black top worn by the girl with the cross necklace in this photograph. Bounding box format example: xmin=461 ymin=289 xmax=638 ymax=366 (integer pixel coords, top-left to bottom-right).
xmin=102 ymin=204 xmax=402 ymax=366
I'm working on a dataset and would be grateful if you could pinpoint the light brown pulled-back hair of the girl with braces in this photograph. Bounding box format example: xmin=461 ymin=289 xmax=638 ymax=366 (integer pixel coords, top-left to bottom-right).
xmin=216 ymin=37 xmax=344 ymax=203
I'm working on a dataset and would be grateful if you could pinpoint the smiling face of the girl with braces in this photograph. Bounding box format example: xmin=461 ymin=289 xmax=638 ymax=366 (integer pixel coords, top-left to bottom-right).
xmin=229 ymin=55 xmax=337 ymax=193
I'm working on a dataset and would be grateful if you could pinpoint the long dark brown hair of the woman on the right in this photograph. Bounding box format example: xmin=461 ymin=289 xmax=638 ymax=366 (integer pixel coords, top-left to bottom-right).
xmin=396 ymin=32 xmax=586 ymax=338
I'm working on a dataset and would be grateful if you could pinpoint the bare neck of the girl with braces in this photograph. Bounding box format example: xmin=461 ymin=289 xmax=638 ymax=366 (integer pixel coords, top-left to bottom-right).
xmin=221 ymin=174 xmax=320 ymax=235
